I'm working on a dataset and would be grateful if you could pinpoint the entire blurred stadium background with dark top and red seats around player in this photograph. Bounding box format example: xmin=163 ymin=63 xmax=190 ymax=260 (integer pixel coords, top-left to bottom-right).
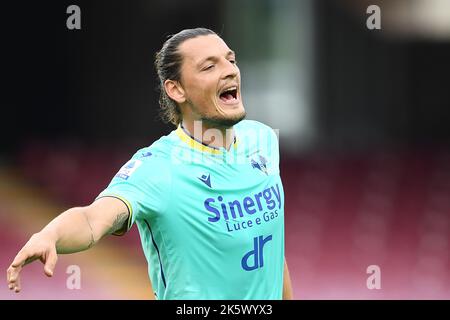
xmin=0 ymin=0 xmax=450 ymax=299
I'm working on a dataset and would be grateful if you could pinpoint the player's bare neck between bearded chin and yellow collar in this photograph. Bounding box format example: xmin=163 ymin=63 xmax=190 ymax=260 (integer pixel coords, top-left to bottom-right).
xmin=181 ymin=120 xmax=235 ymax=150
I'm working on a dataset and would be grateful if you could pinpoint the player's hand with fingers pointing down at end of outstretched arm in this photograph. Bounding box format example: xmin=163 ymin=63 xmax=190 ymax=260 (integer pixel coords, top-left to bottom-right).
xmin=6 ymin=233 xmax=58 ymax=292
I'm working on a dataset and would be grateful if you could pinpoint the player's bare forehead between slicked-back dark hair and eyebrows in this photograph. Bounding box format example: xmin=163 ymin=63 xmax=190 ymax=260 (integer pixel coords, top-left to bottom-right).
xmin=180 ymin=34 xmax=230 ymax=63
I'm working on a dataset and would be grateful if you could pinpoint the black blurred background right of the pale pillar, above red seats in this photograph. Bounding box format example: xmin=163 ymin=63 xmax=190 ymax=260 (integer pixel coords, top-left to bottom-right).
xmin=316 ymin=1 xmax=450 ymax=149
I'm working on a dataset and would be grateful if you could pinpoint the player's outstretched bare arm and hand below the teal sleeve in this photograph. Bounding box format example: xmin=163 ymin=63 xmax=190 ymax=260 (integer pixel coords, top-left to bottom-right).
xmin=7 ymin=197 xmax=131 ymax=292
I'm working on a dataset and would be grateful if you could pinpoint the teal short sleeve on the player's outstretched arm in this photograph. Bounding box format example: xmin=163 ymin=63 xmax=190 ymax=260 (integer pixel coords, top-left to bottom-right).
xmin=96 ymin=152 xmax=171 ymax=231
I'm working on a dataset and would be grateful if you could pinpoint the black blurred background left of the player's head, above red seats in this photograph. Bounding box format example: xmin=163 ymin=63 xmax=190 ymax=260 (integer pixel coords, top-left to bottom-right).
xmin=2 ymin=1 xmax=220 ymax=152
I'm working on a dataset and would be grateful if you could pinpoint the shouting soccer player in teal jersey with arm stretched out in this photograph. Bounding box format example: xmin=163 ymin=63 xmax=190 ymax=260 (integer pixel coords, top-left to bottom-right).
xmin=7 ymin=28 xmax=292 ymax=299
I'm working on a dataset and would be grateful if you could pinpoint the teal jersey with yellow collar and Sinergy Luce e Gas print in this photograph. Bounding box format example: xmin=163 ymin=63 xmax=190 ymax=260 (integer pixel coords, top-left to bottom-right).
xmin=98 ymin=120 xmax=284 ymax=299
